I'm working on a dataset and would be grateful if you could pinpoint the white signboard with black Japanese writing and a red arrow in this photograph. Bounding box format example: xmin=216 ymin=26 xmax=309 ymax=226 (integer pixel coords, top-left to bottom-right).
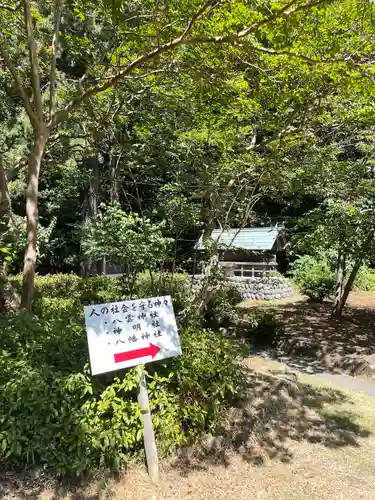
xmin=85 ymin=296 xmax=181 ymax=375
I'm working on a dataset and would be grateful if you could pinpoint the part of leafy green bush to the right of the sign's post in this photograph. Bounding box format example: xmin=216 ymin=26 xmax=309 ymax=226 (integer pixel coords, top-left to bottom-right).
xmin=150 ymin=328 xmax=245 ymax=445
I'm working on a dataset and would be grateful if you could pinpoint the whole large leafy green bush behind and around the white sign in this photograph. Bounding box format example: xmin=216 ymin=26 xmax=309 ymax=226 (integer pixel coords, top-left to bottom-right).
xmin=0 ymin=294 xmax=242 ymax=475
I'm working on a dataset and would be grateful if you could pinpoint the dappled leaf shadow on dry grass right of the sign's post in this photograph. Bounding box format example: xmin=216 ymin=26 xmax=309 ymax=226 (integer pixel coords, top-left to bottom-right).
xmin=173 ymin=369 xmax=370 ymax=475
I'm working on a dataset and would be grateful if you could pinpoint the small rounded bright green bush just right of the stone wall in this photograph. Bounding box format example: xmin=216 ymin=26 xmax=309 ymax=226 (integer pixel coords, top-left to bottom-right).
xmin=291 ymin=255 xmax=335 ymax=302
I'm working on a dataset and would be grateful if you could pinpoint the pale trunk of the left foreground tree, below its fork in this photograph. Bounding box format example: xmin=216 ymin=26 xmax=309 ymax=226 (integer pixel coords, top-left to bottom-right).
xmin=21 ymin=129 xmax=49 ymax=310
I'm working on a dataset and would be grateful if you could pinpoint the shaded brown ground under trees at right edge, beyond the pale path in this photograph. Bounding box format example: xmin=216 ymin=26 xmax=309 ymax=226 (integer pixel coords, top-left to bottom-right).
xmin=242 ymin=293 xmax=375 ymax=376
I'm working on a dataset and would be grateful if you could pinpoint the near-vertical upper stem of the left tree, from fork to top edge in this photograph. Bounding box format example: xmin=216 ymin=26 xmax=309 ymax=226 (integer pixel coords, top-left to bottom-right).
xmin=22 ymin=0 xmax=43 ymax=122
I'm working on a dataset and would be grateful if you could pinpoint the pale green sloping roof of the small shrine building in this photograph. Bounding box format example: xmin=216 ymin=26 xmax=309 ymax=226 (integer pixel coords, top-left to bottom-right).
xmin=196 ymin=227 xmax=280 ymax=250
